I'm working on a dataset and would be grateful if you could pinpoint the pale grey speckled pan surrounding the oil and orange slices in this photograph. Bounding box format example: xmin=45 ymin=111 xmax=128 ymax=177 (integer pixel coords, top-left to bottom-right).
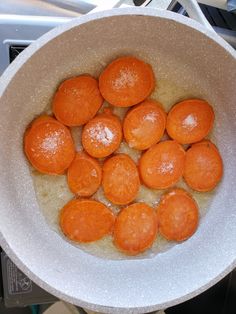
xmin=0 ymin=0 xmax=236 ymax=313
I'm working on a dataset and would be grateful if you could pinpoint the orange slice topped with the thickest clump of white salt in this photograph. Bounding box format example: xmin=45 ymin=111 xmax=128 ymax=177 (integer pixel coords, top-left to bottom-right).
xmin=82 ymin=113 xmax=122 ymax=158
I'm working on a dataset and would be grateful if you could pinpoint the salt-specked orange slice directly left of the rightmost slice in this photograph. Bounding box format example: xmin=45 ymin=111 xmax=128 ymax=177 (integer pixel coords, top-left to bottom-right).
xmin=139 ymin=141 xmax=185 ymax=189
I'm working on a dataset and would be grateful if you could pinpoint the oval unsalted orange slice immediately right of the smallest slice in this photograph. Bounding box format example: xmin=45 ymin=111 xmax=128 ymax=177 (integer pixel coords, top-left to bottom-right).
xmin=102 ymin=154 xmax=140 ymax=205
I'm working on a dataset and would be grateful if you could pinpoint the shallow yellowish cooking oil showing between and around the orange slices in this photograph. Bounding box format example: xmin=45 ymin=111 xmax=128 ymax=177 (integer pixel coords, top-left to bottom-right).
xmin=32 ymin=80 xmax=216 ymax=259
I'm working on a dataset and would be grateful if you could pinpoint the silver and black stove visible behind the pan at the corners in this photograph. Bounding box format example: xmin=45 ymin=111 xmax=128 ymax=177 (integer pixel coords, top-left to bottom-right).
xmin=0 ymin=0 xmax=236 ymax=314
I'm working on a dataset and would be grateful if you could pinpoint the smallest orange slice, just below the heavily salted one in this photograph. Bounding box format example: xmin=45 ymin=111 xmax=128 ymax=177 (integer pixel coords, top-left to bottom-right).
xmin=67 ymin=152 xmax=102 ymax=197
